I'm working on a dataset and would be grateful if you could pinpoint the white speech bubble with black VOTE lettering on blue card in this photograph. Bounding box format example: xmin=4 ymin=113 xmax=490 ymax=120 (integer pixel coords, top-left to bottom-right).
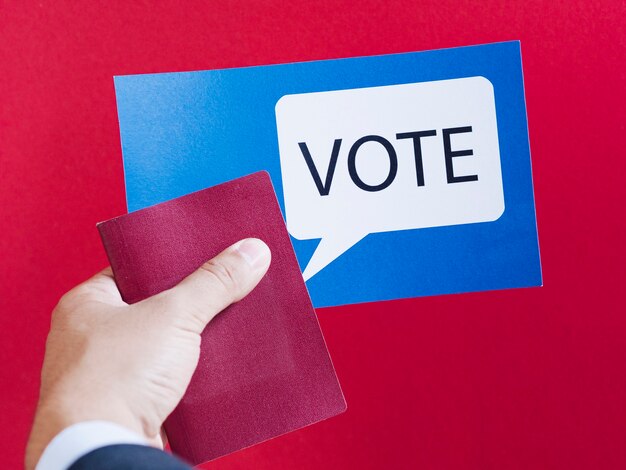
xmin=276 ymin=77 xmax=504 ymax=280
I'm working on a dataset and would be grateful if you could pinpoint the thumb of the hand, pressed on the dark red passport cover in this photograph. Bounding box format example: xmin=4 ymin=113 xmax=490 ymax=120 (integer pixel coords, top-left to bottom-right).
xmin=155 ymin=238 xmax=271 ymax=333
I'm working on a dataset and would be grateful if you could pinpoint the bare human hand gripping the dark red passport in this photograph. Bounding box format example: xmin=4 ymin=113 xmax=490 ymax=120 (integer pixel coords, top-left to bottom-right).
xmin=26 ymin=238 xmax=271 ymax=469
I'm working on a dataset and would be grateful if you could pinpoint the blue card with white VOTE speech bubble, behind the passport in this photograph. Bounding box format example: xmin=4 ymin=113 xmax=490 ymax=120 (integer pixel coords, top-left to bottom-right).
xmin=115 ymin=41 xmax=542 ymax=307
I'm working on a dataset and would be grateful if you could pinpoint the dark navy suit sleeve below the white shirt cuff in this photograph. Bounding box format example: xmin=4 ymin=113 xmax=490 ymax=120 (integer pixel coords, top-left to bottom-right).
xmin=68 ymin=444 xmax=191 ymax=470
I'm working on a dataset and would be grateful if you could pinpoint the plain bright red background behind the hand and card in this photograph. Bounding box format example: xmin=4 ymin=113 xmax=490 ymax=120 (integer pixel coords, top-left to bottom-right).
xmin=0 ymin=0 xmax=626 ymax=469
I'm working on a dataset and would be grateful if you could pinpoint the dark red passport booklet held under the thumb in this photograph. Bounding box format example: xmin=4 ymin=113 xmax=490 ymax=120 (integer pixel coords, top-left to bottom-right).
xmin=98 ymin=172 xmax=346 ymax=464
